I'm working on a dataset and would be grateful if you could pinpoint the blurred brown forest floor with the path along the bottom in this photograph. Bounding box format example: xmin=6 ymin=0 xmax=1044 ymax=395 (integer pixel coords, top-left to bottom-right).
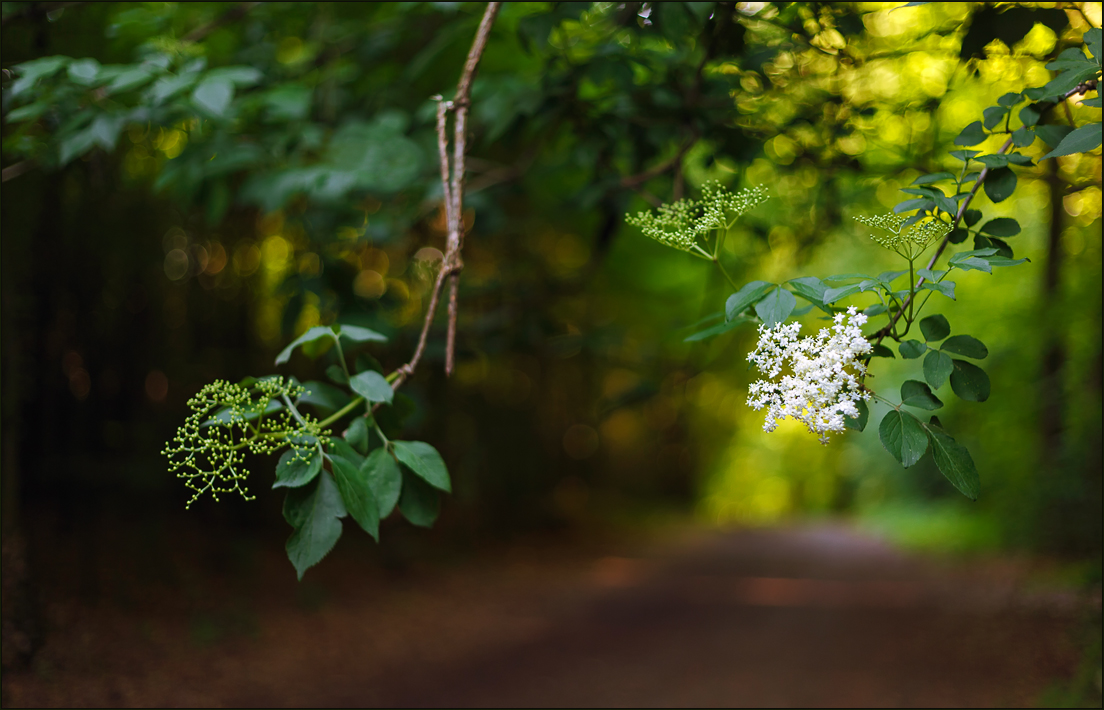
xmin=2 ymin=514 xmax=1100 ymax=708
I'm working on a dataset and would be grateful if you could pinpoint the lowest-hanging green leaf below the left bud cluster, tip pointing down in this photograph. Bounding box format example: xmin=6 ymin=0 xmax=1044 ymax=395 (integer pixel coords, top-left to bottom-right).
xmin=284 ymin=470 xmax=346 ymax=580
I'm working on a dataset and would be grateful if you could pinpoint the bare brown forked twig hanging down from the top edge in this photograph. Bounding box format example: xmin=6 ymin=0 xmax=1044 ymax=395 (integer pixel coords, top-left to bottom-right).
xmin=373 ymin=2 xmax=502 ymax=395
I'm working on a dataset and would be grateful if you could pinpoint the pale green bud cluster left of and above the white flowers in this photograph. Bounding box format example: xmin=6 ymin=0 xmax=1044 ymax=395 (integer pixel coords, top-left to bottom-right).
xmin=625 ymin=182 xmax=767 ymax=252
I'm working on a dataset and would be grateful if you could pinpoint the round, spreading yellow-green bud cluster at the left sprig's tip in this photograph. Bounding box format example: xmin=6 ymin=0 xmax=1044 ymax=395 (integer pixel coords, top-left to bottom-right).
xmin=161 ymin=377 xmax=328 ymax=507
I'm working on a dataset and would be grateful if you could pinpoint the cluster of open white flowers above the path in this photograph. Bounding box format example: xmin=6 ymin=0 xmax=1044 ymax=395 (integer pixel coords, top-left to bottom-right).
xmin=747 ymin=306 xmax=871 ymax=444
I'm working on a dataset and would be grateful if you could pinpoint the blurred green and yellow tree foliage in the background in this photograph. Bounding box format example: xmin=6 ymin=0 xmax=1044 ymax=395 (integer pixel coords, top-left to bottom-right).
xmin=2 ymin=2 xmax=1102 ymax=563
